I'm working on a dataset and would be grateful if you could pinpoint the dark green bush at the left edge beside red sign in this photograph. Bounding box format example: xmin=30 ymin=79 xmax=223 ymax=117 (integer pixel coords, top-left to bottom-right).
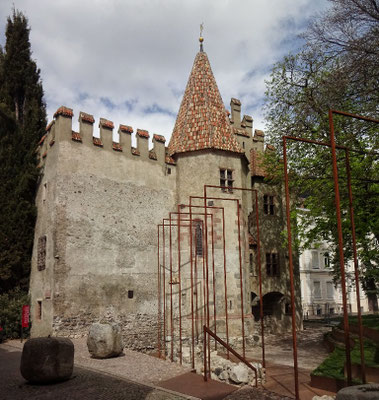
xmin=0 ymin=289 xmax=29 ymax=343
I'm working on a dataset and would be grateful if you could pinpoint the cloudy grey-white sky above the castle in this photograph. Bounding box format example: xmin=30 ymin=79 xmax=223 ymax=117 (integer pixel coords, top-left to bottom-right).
xmin=0 ymin=0 xmax=328 ymax=144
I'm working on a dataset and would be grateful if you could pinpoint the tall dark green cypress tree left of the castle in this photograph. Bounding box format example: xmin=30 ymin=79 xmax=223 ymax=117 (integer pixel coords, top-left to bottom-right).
xmin=0 ymin=10 xmax=46 ymax=292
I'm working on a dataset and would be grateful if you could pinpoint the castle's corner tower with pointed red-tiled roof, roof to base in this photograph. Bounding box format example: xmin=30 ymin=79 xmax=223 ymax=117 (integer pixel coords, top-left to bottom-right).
xmin=168 ymin=38 xmax=251 ymax=337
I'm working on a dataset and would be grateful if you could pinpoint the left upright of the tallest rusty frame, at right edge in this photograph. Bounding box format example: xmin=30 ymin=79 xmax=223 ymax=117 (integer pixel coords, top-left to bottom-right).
xmin=329 ymin=110 xmax=352 ymax=386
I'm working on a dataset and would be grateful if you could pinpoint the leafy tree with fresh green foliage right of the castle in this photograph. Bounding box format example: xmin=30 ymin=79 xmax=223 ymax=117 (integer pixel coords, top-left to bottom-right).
xmin=266 ymin=0 xmax=379 ymax=310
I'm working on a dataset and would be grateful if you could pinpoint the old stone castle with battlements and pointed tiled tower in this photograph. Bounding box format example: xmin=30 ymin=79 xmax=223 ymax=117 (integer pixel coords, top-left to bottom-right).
xmin=30 ymin=39 xmax=301 ymax=356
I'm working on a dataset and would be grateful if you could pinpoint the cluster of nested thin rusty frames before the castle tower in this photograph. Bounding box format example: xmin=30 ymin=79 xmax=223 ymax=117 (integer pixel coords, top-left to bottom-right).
xmin=158 ymin=185 xmax=265 ymax=378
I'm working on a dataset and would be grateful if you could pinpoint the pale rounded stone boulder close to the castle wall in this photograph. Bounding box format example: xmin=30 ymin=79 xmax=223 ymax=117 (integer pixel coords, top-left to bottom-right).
xmin=87 ymin=323 xmax=124 ymax=358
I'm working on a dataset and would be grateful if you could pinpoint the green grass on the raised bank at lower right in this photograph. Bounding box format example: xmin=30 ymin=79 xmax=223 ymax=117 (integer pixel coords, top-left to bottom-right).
xmin=312 ymin=339 xmax=379 ymax=383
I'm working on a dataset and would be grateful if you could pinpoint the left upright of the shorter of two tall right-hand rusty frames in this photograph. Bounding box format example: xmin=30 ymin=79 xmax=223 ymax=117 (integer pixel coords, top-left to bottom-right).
xmin=283 ymin=137 xmax=300 ymax=400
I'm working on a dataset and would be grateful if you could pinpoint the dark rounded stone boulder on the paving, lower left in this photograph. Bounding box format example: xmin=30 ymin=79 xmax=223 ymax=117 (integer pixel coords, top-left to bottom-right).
xmin=20 ymin=337 xmax=74 ymax=383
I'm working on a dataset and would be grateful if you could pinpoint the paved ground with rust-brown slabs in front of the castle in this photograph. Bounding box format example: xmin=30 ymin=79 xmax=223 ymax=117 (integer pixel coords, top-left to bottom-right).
xmin=0 ymin=328 xmax=336 ymax=400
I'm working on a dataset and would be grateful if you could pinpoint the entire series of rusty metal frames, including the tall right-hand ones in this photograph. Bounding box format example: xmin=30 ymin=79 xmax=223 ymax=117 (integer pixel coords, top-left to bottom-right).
xmin=158 ymin=110 xmax=379 ymax=399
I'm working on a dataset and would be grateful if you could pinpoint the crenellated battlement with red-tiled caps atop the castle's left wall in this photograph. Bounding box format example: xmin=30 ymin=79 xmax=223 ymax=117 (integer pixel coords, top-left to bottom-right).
xmin=36 ymin=106 xmax=175 ymax=167
